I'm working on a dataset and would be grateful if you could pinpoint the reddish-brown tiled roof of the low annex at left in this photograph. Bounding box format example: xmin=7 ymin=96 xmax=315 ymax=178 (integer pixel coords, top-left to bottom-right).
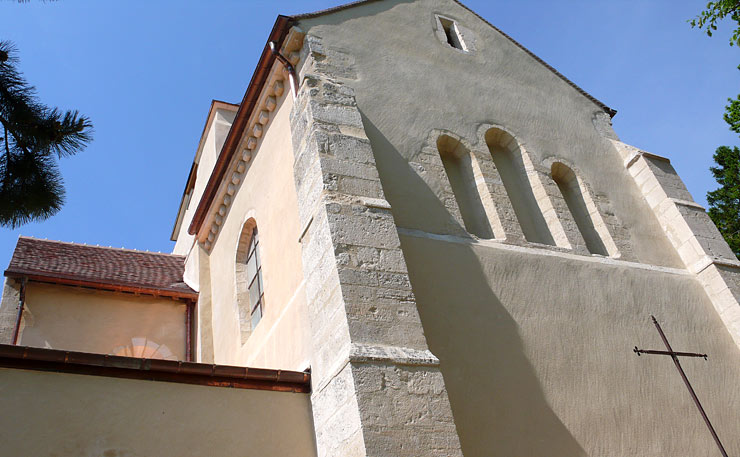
xmin=5 ymin=236 xmax=197 ymax=298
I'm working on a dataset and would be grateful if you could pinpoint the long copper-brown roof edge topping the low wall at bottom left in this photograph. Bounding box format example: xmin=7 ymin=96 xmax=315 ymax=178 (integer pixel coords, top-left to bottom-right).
xmin=0 ymin=344 xmax=311 ymax=393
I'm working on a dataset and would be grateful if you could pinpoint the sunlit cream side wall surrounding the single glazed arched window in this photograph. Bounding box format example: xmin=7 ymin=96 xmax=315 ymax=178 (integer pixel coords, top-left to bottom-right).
xmin=200 ymin=91 xmax=309 ymax=371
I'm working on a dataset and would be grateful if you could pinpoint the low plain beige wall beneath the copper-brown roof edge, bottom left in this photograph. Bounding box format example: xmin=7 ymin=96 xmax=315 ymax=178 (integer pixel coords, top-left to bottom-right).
xmin=0 ymin=369 xmax=316 ymax=457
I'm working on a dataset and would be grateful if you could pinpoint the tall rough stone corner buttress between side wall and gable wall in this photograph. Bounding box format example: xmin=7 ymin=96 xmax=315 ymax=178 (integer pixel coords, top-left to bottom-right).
xmin=291 ymin=35 xmax=462 ymax=456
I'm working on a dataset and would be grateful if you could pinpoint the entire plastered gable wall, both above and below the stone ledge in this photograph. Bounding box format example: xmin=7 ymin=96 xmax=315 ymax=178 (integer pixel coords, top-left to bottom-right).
xmin=300 ymin=0 xmax=740 ymax=456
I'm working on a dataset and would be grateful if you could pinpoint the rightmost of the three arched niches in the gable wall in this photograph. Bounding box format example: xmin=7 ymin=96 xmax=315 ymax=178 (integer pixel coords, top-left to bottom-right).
xmin=551 ymin=162 xmax=616 ymax=256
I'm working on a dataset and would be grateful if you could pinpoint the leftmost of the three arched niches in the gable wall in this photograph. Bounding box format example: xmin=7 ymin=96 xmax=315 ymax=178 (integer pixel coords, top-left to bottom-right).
xmin=437 ymin=135 xmax=493 ymax=239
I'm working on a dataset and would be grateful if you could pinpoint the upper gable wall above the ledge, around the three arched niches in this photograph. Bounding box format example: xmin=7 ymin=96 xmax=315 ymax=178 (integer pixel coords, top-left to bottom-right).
xmin=300 ymin=0 xmax=682 ymax=267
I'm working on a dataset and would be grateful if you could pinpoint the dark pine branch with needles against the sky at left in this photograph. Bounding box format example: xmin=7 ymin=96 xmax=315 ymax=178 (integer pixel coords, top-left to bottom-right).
xmin=0 ymin=41 xmax=92 ymax=228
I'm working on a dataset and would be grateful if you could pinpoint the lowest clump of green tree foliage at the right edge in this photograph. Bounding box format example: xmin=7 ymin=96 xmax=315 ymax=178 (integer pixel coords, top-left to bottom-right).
xmin=707 ymin=146 xmax=740 ymax=259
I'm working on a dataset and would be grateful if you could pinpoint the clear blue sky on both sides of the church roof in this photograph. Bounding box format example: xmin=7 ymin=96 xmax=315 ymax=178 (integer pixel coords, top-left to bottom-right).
xmin=0 ymin=0 xmax=740 ymax=269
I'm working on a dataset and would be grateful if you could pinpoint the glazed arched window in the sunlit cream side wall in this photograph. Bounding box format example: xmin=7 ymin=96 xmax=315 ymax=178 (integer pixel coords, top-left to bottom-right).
xmin=236 ymin=219 xmax=265 ymax=343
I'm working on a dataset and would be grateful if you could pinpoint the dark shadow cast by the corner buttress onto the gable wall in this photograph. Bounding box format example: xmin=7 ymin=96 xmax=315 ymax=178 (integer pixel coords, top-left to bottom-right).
xmin=363 ymin=117 xmax=586 ymax=457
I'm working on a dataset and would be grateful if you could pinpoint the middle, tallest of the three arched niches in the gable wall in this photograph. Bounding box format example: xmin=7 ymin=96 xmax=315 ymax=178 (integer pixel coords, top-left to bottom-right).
xmin=486 ymin=128 xmax=555 ymax=246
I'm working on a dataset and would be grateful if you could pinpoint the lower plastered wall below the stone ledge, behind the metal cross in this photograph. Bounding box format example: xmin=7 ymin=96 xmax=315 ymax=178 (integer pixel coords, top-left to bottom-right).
xmin=401 ymin=233 xmax=740 ymax=457
